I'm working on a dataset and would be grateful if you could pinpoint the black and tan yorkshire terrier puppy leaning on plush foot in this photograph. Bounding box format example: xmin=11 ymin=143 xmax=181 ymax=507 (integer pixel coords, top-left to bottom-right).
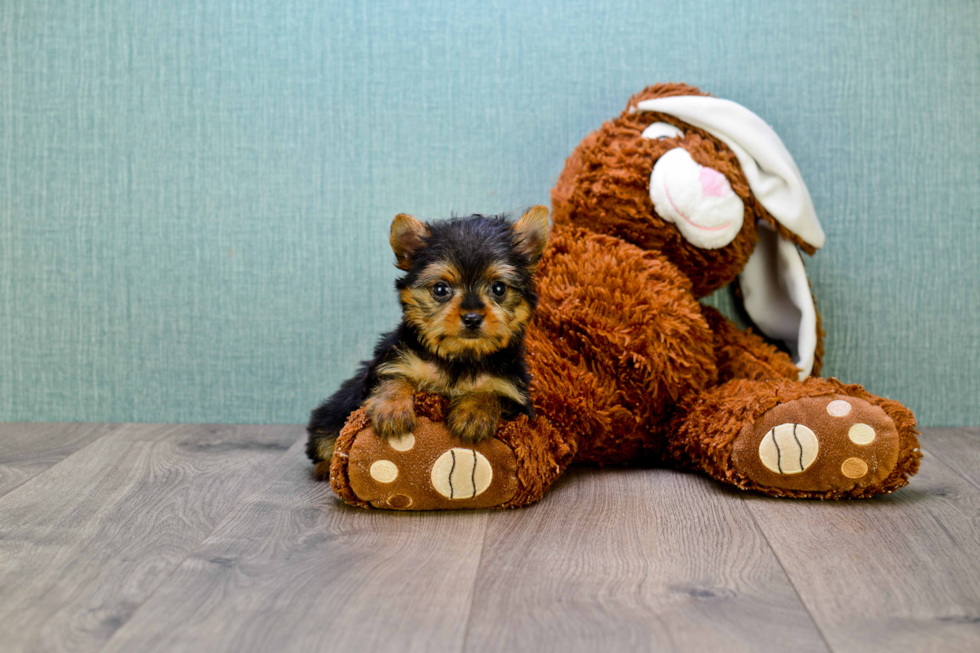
xmin=306 ymin=206 xmax=548 ymax=468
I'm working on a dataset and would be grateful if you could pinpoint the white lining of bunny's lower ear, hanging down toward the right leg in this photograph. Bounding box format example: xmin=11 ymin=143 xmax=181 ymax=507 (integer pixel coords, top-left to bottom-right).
xmin=738 ymin=222 xmax=817 ymax=381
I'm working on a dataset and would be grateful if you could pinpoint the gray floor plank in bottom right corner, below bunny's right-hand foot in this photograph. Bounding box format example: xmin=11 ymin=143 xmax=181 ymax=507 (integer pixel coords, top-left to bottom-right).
xmin=746 ymin=433 xmax=980 ymax=653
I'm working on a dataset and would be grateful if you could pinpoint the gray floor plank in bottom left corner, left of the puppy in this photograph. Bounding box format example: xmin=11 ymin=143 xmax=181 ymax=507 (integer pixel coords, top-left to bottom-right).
xmin=0 ymin=425 xmax=302 ymax=652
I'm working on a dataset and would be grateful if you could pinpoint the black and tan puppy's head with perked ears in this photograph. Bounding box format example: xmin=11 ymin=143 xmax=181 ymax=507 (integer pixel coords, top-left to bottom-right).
xmin=391 ymin=206 xmax=548 ymax=360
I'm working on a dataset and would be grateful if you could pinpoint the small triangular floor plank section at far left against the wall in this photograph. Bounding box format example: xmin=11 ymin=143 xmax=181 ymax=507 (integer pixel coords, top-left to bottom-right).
xmin=0 ymin=422 xmax=120 ymax=497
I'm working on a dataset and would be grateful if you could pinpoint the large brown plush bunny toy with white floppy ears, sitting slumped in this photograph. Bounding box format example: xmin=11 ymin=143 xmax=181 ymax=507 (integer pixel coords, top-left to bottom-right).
xmin=329 ymin=84 xmax=921 ymax=510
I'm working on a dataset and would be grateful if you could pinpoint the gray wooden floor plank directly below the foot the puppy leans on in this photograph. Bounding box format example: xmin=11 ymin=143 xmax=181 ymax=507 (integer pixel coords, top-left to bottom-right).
xmin=97 ymin=444 xmax=487 ymax=653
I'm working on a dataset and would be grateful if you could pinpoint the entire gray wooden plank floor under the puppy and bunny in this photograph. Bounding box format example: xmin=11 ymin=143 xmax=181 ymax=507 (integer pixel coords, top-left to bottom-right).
xmin=0 ymin=424 xmax=980 ymax=653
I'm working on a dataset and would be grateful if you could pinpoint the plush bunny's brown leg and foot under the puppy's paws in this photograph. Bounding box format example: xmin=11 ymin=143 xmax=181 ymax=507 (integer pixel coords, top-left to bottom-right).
xmin=330 ymin=393 xmax=575 ymax=510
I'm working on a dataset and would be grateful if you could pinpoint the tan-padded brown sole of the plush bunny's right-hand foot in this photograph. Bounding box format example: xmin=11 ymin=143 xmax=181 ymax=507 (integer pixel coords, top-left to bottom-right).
xmin=732 ymin=395 xmax=899 ymax=493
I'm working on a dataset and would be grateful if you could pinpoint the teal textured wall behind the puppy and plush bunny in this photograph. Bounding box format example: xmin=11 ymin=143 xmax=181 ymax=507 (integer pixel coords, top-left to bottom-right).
xmin=0 ymin=0 xmax=980 ymax=425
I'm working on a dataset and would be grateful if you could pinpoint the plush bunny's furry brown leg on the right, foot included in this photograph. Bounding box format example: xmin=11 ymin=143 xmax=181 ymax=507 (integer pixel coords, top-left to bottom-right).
xmin=668 ymin=378 xmax=921 ymax=499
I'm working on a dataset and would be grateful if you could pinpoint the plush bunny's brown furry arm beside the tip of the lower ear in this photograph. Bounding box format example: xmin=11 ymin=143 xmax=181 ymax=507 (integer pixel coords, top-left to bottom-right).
xmin=701 ymin=305 xmax=799 ymax=383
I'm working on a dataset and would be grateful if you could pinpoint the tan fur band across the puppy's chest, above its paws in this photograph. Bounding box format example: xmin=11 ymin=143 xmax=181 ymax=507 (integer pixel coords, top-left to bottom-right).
xmin=378 ymin=351 xmax=524 ymax=403
